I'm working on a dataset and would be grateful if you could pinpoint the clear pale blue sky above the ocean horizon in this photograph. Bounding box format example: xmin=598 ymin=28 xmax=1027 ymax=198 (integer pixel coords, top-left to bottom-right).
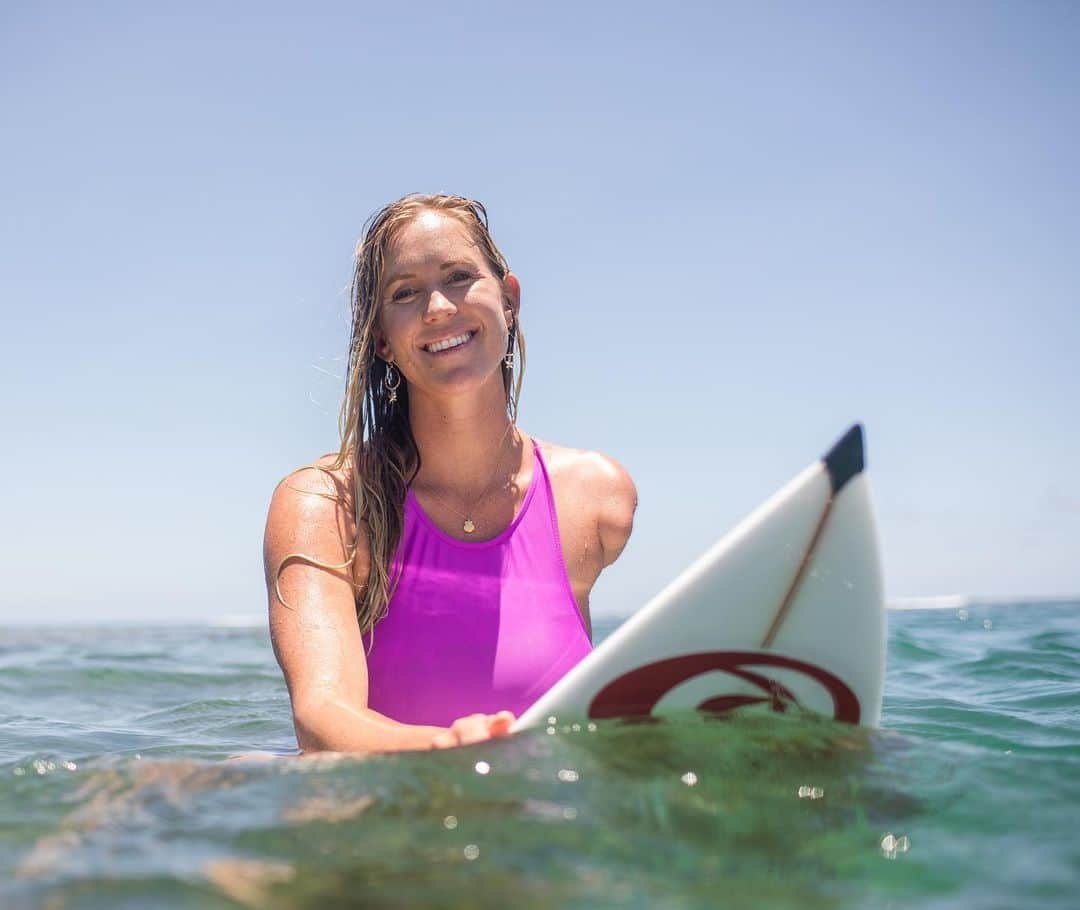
xmin=0 ymin=0 xmax=1080 ymax=624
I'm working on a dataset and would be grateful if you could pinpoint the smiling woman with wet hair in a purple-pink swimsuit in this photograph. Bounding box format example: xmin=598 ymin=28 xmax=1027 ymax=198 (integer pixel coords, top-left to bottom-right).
xmin=265 ymin=195 xmax=636 ymax=751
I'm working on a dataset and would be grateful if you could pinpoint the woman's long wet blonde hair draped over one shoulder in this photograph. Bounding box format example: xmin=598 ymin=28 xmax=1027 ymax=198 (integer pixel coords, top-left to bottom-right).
xmin=275 ymin=193 xmax=525 ymax=633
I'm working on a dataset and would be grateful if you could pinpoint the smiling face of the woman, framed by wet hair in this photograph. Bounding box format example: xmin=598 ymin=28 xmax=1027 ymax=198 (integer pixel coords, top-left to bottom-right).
xmin=376 ymin=210 xmax=521 ymax=403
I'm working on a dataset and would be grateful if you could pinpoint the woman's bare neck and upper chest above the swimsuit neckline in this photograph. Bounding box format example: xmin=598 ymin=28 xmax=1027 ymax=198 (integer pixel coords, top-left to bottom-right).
xmin=409 ymin=389 xmax=521 ymax=498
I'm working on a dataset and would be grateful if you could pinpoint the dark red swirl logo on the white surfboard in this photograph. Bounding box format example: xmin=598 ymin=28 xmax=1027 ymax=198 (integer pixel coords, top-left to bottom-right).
xmin=589 ymin=651 xmax=862 ymax=723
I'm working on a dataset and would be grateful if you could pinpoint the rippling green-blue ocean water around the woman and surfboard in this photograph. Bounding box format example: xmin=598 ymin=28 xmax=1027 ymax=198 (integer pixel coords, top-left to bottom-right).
xmin=0 ymin=602 xmax=1080 ymax=910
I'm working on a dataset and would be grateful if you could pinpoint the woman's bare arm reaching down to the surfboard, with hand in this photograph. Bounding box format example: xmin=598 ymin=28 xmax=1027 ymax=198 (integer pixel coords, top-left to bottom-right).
xmin=264 ymin=459 xmax=513 ymax=752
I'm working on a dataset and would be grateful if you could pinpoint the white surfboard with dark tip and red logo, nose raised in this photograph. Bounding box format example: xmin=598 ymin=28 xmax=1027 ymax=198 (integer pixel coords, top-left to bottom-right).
xmin=514 ymin=424 xmax=886 ymax=731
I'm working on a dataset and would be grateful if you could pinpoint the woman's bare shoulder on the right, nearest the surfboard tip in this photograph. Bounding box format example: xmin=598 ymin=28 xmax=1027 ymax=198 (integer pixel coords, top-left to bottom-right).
xmin=537 ymin=439 xmax=637 ymax=565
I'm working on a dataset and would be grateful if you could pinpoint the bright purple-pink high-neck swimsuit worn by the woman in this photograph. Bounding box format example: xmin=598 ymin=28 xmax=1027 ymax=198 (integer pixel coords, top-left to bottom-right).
xmin=364 ymin=440 xmax=592 ymax=726
